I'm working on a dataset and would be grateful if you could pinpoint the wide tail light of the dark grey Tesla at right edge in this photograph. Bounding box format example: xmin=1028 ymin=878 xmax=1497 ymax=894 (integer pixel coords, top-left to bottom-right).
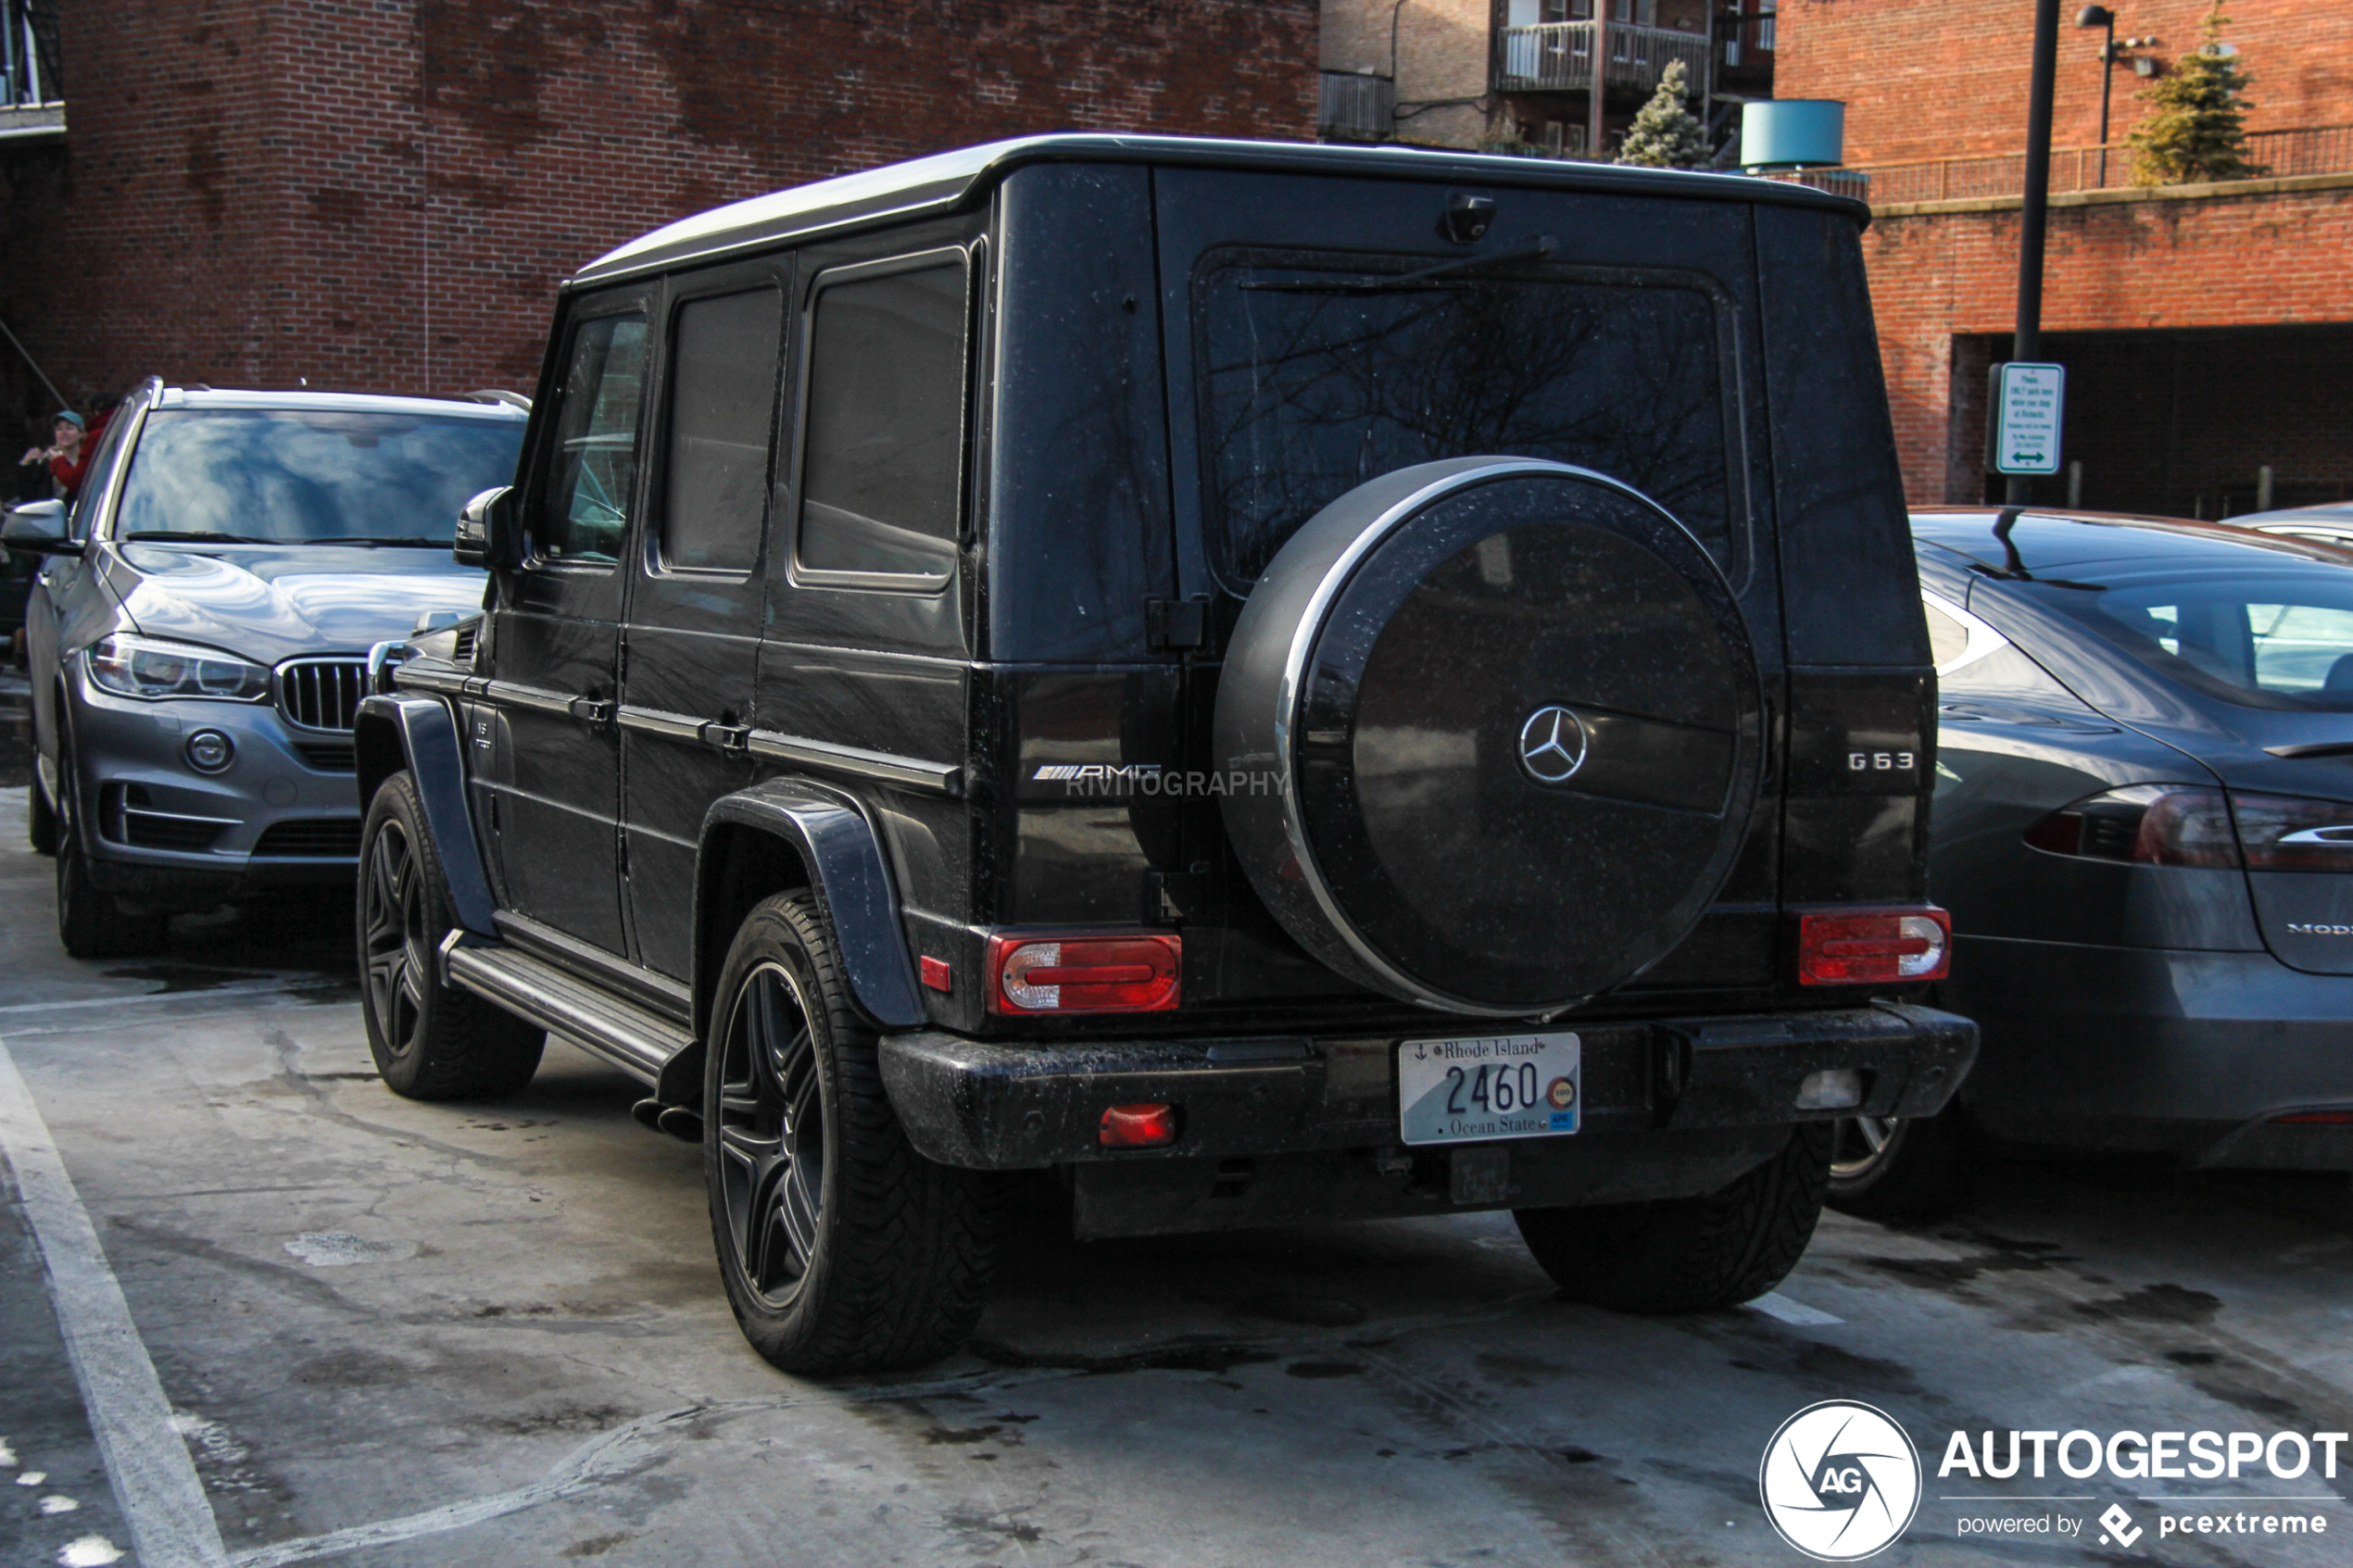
xmin=2026 ymin=785 xmax=2353 ymax=872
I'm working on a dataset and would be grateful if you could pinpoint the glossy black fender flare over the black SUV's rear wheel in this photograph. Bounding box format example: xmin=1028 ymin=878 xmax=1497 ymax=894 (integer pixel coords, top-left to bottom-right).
xmin=694 ymin=778 xmax=929 ymax=1036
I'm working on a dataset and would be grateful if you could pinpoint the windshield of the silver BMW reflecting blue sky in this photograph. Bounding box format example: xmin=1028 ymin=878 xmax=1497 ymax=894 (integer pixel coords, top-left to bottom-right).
xmin=108 ymin=409 xmax=522 ymax=547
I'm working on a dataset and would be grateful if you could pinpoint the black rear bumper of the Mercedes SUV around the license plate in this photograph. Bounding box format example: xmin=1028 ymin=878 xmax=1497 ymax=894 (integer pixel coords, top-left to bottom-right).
xmin=883 ymin=1004 xmax=1977 ymax=1175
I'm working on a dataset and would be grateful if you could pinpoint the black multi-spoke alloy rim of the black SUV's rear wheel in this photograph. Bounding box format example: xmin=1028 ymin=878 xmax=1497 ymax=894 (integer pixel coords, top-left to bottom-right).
xmin=718 ymin=961 xmax=826 ymax=1311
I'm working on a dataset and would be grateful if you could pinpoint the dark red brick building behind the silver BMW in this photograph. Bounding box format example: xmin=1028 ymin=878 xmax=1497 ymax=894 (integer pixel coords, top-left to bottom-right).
xmin=0 ymin=0 xmax=1317 ymax=425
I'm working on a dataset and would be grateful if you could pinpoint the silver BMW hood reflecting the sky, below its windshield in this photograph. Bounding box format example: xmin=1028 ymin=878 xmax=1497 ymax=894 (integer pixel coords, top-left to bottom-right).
xmin=106 ymin=546 xmax=484 ymax=665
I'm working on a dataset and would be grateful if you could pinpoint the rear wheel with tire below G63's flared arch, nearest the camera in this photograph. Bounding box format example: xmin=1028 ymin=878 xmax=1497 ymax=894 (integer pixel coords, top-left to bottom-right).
xmin=703 ymin=896 xmax=998 ymax=1373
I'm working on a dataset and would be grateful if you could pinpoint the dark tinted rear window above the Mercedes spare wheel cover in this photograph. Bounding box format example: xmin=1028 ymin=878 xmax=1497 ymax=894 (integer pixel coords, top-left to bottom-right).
xmin=1195 ymin=249 xmax=1739 ymax=588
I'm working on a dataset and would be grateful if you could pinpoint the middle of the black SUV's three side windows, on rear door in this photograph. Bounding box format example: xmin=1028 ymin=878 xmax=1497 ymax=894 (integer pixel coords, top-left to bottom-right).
xmin=661 ymin=289 xmax=784 ymax=571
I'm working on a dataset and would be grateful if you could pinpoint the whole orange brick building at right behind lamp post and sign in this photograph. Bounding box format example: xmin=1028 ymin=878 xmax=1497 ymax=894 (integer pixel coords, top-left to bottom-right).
xmin=1777 ymin=0 xmax=2353 ymax=517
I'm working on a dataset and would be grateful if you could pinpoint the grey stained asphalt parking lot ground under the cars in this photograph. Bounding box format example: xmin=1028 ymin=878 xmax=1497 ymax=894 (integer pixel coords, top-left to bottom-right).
xmin=0 ymin=775 xmax=2353 ymax=1568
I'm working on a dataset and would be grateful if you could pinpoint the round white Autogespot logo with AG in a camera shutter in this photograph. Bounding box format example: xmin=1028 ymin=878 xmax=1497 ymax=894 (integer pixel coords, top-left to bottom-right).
xmin=1757 ymin=1399 xmax=1920 ymax=1563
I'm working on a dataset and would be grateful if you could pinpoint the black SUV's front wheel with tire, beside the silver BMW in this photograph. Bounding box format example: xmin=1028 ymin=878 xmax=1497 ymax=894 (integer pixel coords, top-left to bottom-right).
xmin=353 ymin=773 xmax=548 ymax=1100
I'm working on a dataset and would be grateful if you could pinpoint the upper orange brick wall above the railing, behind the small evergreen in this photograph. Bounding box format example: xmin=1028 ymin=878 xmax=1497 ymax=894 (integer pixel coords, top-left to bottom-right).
xmin=1774 ymin=0 xmax=2353 ymax=165
